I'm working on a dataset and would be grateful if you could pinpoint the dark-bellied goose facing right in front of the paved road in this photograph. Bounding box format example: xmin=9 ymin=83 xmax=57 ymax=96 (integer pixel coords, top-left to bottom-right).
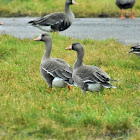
xmin=28 ymin=0 xmax=78 ymax=32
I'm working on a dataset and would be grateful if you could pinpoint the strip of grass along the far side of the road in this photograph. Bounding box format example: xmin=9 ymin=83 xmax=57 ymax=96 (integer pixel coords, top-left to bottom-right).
xmin=0 ymin=0 xmax=140 ymax=17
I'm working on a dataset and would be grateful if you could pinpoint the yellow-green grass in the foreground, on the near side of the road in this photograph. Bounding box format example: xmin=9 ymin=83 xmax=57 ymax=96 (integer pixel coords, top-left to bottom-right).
xmin=0 ymin=34 xmax=140 ymax=140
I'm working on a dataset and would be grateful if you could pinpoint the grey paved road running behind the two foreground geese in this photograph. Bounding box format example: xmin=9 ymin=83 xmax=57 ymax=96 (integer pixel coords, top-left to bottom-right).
xmin=0 ymin=17 xmax=140 ymax=45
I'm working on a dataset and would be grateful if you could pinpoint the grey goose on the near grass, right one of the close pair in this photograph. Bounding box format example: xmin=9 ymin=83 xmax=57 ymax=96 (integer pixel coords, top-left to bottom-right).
xmin=66 ymin=43 xmax=116 ymax=93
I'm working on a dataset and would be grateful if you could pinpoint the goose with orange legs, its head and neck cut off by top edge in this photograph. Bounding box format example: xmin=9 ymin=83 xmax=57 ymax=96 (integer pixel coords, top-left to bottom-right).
xmin=116 ymin=0 xmax=135 ymax=19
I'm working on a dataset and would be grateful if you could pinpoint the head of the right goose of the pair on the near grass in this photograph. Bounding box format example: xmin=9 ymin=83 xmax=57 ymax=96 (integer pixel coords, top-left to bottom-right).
xmin=66 ymin=42 xmax=83 ymax=52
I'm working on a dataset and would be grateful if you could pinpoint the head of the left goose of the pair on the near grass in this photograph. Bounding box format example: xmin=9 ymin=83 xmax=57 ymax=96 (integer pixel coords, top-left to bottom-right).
xmin=34 ymin=33 xmax=51 ymax=42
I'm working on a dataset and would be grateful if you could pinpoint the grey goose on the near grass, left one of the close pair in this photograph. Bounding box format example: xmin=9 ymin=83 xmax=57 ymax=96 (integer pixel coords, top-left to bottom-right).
xmin=34 ymin=33 xmax=73 ymax=90
